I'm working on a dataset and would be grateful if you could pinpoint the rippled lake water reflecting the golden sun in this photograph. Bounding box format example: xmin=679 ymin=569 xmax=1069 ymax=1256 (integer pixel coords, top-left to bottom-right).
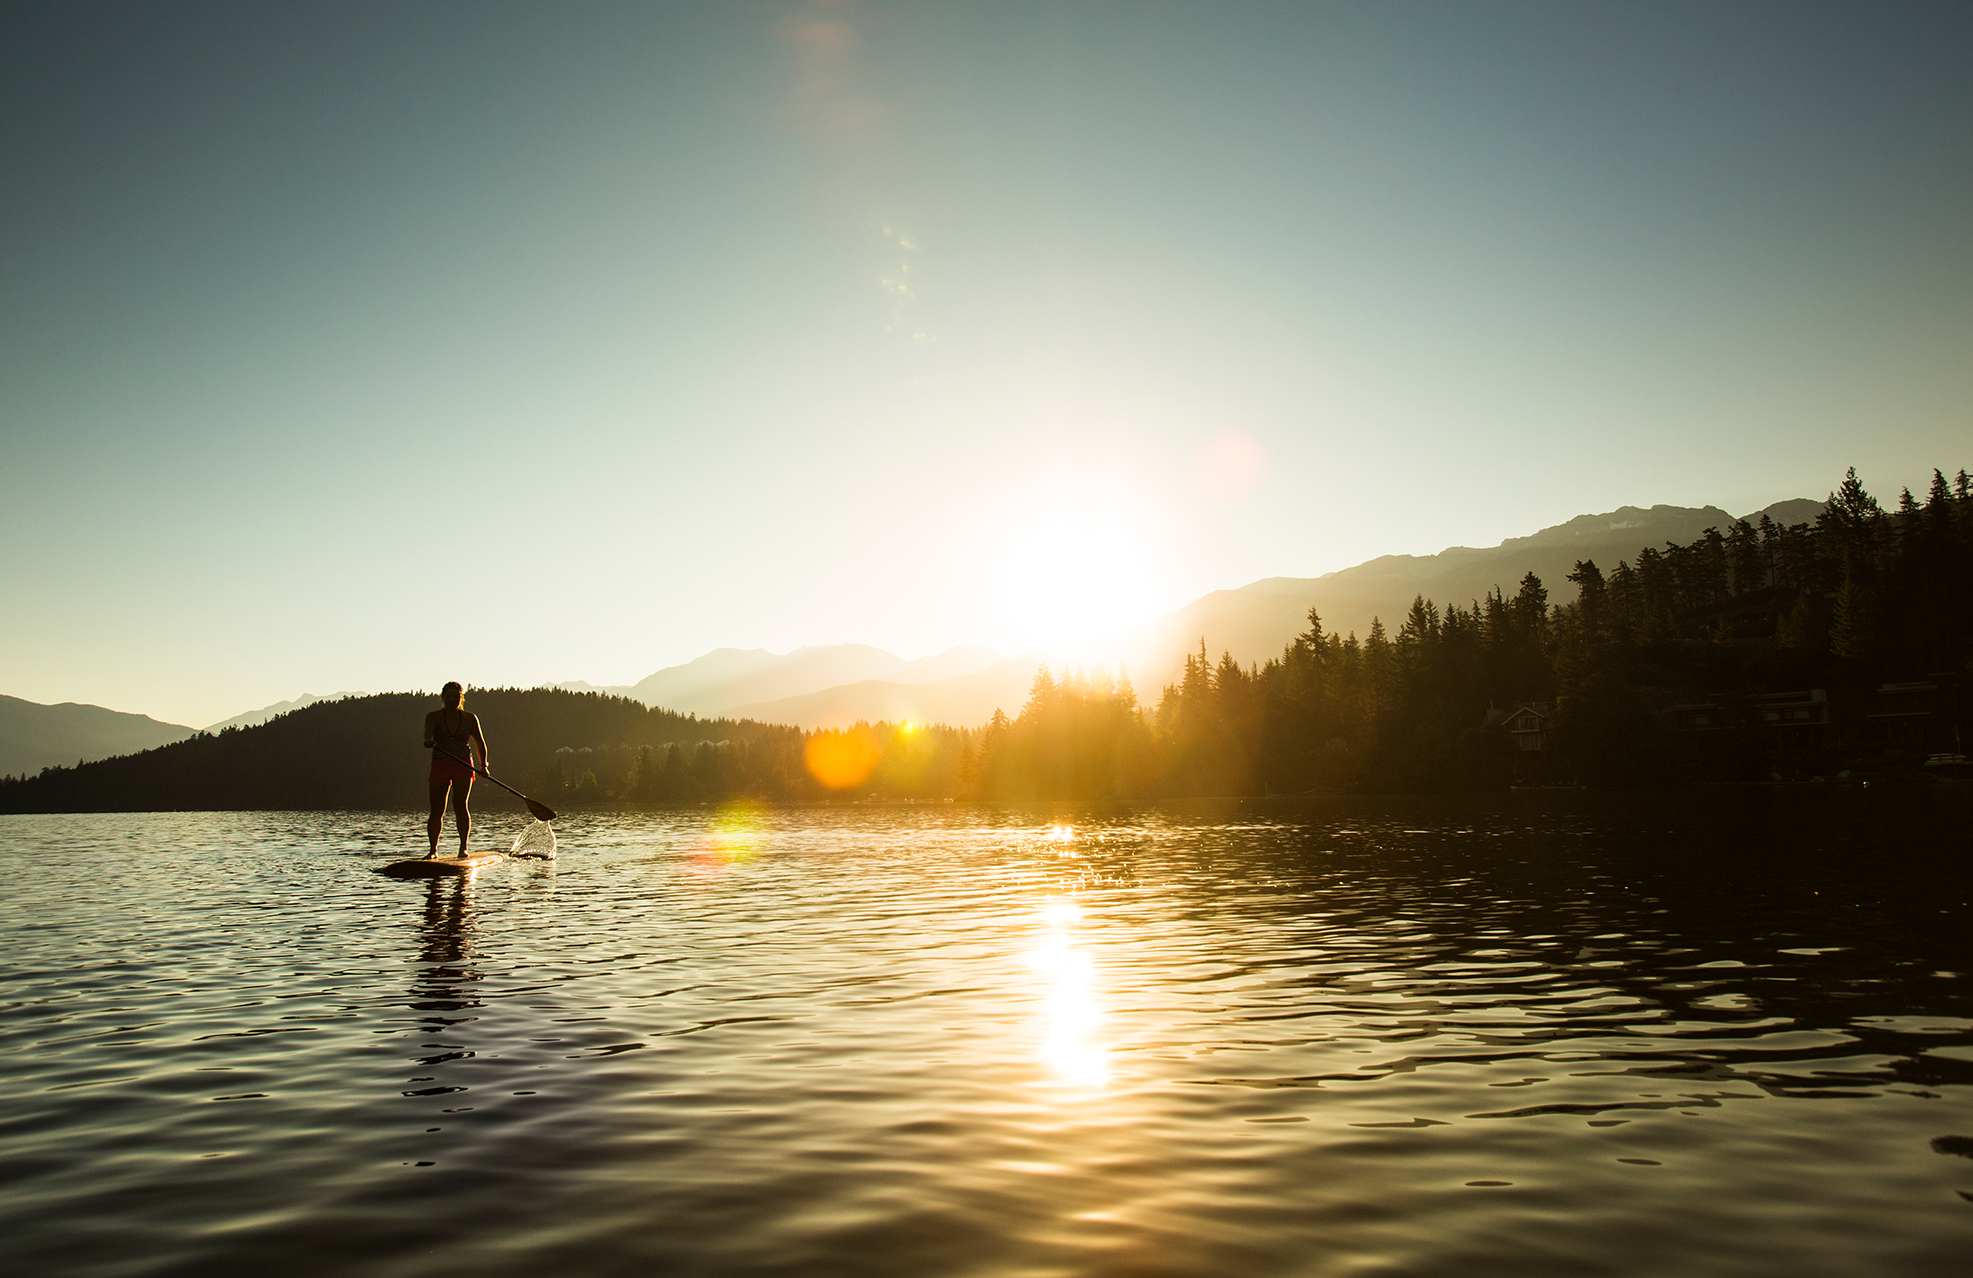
xmin=0 ymin=787 xmax=1973 ymax=1276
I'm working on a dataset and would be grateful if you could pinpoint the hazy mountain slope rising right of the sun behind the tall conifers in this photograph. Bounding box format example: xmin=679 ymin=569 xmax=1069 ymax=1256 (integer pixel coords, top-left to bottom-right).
xmin=1109 ymin=499 xmax=1823 ymax=700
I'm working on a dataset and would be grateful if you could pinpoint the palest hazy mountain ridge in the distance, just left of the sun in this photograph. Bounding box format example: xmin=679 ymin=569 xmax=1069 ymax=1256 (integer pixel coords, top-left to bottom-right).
xmin=623 ymin=643 xmax=1002 ymax=716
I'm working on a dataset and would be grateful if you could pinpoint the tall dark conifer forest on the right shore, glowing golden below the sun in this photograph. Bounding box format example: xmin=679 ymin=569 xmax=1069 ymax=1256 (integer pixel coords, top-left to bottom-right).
xmin=977 ymin=469 xmax=1973 ymax=799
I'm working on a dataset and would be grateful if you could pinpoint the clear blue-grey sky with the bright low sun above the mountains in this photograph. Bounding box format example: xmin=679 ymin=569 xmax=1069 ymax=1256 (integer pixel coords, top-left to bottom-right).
xmin=0 ymin=2 xmax=1973 ymax=724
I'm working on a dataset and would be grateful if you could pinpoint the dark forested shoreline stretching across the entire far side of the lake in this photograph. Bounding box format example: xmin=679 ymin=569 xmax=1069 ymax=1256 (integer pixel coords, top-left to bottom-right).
xmin=0 ymin=471 xmax=1973 ymax=813
